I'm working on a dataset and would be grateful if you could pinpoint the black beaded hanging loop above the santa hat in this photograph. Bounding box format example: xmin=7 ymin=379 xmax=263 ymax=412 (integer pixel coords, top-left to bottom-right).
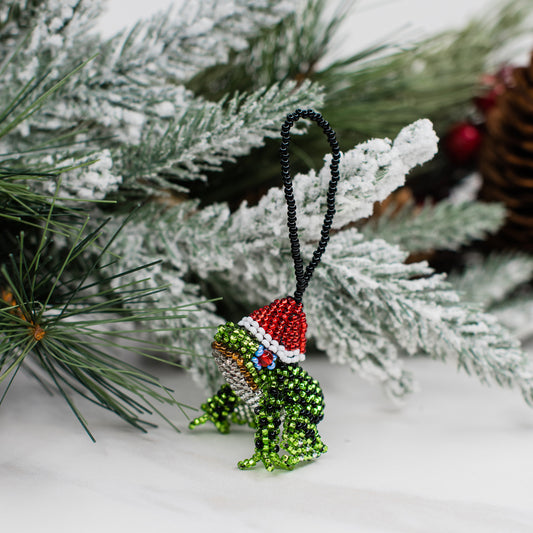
xmin=279 ymin=109 xmax=341 ymax=302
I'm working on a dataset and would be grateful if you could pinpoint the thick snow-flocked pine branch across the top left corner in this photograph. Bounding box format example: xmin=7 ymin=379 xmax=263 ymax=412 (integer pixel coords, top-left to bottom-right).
xmin=0 ymin=0 xmax=298 ymax=151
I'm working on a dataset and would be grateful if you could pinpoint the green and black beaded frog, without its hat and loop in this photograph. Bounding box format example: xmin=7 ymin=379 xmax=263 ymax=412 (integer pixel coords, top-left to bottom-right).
xmin=189 ymin=312 xmax=327 ymax=471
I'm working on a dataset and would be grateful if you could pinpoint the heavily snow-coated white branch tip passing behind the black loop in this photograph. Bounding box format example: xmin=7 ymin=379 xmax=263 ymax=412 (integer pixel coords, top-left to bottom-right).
xmin=224 ymin=119 xmax=438 ymax=241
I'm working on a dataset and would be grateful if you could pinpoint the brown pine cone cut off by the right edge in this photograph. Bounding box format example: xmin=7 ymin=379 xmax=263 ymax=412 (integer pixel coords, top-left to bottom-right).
xmin=479 ymin=56 xmax=533 ymax=252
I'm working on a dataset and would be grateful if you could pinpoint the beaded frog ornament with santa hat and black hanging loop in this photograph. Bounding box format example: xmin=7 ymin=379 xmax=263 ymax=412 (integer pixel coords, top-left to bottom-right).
xmin=189 ymin=109 xmax=340 ymax=471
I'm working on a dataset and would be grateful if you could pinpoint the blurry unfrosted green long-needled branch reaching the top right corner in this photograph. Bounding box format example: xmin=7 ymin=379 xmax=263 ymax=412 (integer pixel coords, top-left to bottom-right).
xmin=314 ymin=0 xmax=531 ymax=142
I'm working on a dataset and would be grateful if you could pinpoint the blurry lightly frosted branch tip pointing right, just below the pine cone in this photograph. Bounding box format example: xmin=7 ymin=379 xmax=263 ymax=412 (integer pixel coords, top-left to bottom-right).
xmin=361 ymin=200 xmax=505 ymax=253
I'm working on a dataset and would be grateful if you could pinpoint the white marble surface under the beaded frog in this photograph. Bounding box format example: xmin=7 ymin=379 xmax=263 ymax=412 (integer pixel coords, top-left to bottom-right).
xmin=0 ymin=357 xmax=533 ymax=533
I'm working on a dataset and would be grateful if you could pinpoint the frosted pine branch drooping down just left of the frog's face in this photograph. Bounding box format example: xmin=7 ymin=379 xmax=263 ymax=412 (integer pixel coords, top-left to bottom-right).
xmin=101 ymin=210 xmax=224 ymax=391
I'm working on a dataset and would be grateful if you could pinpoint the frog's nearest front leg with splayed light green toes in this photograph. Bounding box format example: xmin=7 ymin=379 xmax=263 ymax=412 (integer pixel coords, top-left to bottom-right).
xmin=238 ymin=388 xmax=292 ymax=472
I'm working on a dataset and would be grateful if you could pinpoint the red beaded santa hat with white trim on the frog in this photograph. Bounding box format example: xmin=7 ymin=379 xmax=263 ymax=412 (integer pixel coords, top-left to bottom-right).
xmin=239 ymin=296 xmax=307 ymax=363
